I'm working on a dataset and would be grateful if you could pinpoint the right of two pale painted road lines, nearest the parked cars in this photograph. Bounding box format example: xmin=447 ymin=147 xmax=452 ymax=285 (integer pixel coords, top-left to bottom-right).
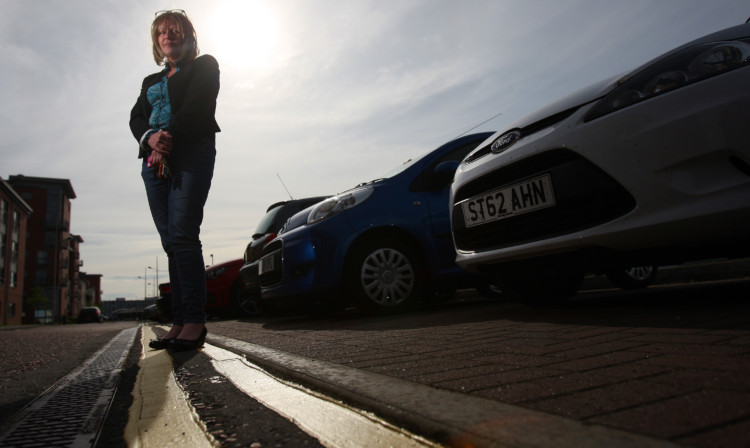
xmin=203 ymin=344 xmax=439 ymax=447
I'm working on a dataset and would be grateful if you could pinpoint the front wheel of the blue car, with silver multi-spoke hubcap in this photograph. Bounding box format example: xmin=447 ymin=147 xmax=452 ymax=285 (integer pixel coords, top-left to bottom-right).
xmin=347 ymin=238 xmax=425 ymax=312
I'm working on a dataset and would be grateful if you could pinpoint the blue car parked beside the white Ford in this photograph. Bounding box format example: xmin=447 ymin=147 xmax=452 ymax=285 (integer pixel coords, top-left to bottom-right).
xmin=258 ymin=132 xmax=497 ymax=311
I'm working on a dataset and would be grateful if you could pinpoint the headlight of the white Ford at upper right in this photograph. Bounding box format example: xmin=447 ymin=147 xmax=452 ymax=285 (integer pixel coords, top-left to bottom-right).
xmin=585 ymin=39 xmax=750 ymax=121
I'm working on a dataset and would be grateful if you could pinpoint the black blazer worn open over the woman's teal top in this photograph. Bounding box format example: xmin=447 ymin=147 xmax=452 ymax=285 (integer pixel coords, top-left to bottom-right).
xmin=130 ymin=55 xmax=221 ymax=157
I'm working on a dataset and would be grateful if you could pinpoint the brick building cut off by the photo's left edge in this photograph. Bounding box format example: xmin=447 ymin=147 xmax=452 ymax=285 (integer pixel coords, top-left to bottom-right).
xmin=0 ymin=178 xmax=32 ymax=325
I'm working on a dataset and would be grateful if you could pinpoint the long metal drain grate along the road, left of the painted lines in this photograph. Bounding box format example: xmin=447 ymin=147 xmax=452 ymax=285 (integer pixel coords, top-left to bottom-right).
xmin=0 ymin=327 xmax=140 ymax=448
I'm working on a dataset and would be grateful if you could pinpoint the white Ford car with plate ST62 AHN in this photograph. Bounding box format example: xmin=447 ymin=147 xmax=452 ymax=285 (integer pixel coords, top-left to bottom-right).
xmin=450 ymin=24 xmax=750 ymax=302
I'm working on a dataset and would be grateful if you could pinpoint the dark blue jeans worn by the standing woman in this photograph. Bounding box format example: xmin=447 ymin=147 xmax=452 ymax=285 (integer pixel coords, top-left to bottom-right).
xmin=141 ymin=138 xmax=216 ymax=325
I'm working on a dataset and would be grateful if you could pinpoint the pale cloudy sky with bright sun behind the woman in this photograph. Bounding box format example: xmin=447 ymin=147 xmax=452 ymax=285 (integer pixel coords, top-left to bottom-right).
xmin=0 ymin=0 xmax=750 ymax=299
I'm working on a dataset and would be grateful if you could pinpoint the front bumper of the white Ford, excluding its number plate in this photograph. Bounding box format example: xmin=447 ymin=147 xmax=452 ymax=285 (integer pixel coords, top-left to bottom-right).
xmin=451 ymin=68 xmax=750 ymax=271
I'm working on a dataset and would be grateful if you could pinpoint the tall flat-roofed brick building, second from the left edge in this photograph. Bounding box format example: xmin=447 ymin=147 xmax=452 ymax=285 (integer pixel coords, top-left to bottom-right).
xmin=8 ymin=175 xmax=83 ymax=323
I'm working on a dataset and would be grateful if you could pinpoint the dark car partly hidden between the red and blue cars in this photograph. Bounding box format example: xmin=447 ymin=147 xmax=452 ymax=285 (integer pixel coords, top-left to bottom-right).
xmin=239 ymin=196 xmax=330 ymax=315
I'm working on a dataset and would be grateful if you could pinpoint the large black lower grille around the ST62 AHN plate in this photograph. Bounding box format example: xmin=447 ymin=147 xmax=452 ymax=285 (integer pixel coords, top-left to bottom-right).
xmin=452 ymin=149 xmax=635 ymax=252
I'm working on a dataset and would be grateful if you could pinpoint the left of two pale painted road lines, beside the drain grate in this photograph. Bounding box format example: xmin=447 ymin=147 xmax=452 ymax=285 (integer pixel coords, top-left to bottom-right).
xmin=124 ymin=325 xmax=215 ymax=448
